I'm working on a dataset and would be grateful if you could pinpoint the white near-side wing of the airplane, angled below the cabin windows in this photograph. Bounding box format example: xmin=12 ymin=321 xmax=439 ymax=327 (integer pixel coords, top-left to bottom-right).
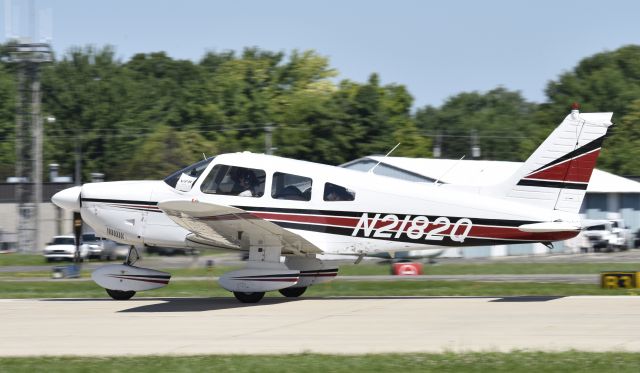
xmin=158 ymin=200 xmax=322 ymax=255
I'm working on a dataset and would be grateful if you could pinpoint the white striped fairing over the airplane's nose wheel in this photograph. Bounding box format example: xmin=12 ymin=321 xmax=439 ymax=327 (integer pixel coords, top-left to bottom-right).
xmin=91 ymin=264 xmax=171 ymax=291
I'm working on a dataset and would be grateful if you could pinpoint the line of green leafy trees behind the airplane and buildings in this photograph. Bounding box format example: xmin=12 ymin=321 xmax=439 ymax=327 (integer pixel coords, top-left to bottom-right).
xmin=0 ymin=45 xmax=640 ymax=180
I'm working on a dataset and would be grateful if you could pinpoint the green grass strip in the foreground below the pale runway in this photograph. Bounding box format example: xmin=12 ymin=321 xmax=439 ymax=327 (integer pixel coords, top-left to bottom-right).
xmin=0 ymin=351 xmax=640 ymax=373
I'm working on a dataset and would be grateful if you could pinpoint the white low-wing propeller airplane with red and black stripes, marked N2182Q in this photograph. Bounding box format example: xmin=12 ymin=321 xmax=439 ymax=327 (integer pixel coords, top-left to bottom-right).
xmin=52 ymin=108 xmax=612 ymax=302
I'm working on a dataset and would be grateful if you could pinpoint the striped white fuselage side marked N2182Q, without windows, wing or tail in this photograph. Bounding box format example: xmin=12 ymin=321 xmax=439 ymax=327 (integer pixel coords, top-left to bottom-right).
xmin=76 ymin=152 xmax=579 ymax=254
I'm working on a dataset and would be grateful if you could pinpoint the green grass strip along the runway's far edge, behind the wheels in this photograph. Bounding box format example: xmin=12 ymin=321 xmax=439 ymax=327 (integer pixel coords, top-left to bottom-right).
xmin=0 ymin=280 xmax=640 ymax=298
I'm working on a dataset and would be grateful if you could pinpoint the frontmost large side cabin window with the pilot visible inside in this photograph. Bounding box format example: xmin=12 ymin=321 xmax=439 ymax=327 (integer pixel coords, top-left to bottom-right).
xmin=200 ymin=164 xmax=266 ymax=197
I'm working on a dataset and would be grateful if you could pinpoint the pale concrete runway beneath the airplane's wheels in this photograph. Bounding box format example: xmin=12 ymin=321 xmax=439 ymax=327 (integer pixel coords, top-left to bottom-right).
xmin=0 ymin=296 xmax=640 ymax=356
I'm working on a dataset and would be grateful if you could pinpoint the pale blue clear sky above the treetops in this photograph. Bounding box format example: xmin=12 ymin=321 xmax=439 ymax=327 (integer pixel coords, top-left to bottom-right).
xmin=0 ymin=0 xmax=640 ymax=108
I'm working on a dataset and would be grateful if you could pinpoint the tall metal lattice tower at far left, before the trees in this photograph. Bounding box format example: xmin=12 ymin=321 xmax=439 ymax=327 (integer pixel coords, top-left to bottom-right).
xmin=9 ymin=43 xmax=51 ymax=252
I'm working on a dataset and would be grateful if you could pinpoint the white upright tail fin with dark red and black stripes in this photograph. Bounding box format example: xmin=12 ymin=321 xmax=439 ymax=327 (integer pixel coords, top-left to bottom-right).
xmin=493 ymin=109 xmax=613 ymax=213
